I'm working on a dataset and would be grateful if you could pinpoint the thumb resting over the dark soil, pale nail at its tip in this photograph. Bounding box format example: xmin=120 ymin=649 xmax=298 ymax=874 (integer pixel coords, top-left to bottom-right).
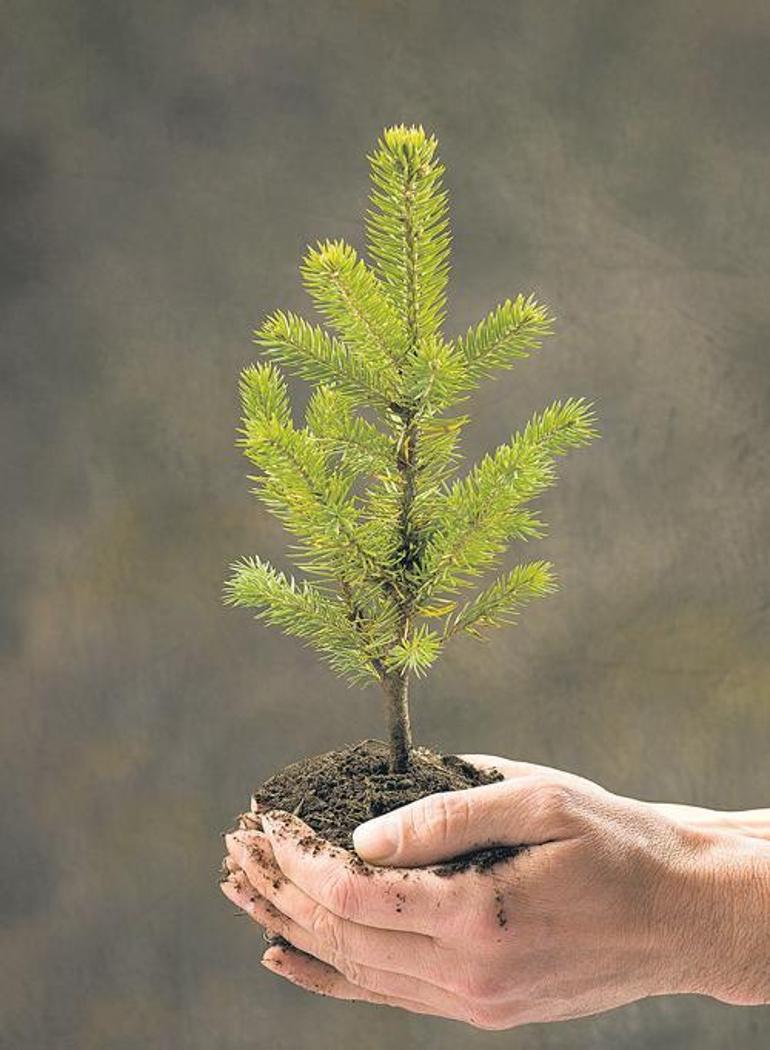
xmin=353 ymin=778 xmax=568 ymax=867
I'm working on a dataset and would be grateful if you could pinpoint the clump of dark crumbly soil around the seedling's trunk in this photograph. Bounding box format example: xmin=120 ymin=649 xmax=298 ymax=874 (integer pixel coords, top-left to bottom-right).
xmin=243 ymin=740 xmax=525 ymax=876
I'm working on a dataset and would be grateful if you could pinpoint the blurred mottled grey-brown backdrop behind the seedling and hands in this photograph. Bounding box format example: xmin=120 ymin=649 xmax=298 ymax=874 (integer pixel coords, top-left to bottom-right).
xmin=0 ymin=0 xmax=770 ymax=1050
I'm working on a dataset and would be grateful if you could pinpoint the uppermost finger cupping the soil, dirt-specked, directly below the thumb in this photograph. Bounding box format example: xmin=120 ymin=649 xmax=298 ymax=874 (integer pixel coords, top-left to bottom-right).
xmin=252 ymin=810 xmax=455 ymax=936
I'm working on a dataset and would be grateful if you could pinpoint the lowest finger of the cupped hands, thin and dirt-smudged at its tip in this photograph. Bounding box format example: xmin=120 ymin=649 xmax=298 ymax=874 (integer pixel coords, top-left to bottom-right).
xmin=262 ymin=946 xmax=467 ymax=1021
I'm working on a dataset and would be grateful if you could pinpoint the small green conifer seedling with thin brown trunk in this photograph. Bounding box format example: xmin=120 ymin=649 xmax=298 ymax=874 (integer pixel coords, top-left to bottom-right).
xmin=225 ymin=125 xmax=596 ymax=772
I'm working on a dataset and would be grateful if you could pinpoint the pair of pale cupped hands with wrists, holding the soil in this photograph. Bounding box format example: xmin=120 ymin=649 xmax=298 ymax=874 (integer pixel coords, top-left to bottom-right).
xmin=222 ymin=755 xmax=770 ymax=1029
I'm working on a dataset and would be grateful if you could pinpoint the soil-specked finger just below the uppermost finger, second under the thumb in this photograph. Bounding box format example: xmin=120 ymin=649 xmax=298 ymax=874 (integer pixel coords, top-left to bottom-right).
xmin=228 ymin=833 xmax=436 ymax=977
